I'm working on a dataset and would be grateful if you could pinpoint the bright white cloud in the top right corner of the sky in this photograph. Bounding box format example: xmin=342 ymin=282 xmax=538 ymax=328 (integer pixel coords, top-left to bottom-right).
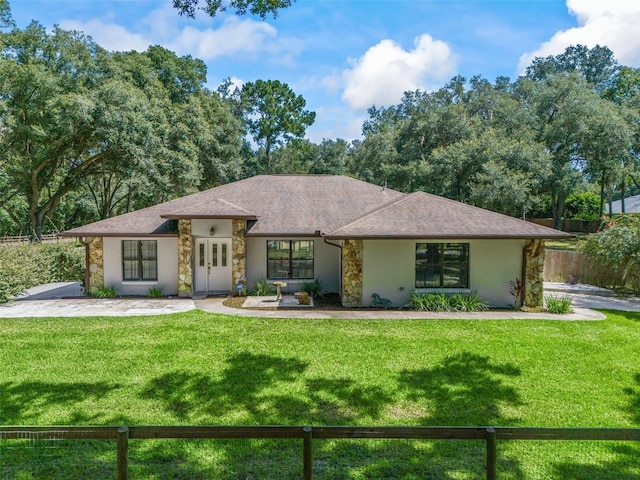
xmin=518 ymin=0 xmax=640 ymax=73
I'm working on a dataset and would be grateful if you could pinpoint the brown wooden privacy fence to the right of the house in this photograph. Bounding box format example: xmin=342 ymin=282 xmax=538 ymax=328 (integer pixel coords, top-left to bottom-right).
xmin=544 ymin=248 xmax=640 ymax=289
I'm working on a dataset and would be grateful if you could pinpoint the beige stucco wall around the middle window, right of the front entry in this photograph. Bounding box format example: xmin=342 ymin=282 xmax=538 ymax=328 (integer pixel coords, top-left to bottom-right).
xmin=247 ymin=237 xmax=340 ymax=292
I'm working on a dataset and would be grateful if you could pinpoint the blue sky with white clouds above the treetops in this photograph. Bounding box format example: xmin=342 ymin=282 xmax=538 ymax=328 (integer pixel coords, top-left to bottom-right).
xmin=9 ymin=0 xmax=640 ymax=142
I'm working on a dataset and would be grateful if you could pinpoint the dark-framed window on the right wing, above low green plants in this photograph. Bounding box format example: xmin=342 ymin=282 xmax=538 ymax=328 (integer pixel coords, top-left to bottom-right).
xmin=416 ymin=243 xmax=469 ymax=288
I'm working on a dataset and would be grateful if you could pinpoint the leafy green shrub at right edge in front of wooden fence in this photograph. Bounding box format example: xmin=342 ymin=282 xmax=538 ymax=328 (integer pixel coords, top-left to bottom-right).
xmin=580 ymin=213 xmax=640 ymax=284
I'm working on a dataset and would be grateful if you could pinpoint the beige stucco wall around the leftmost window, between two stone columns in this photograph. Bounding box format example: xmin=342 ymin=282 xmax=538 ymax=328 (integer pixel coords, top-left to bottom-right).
xmin=103 ymin=237 xmax=178 ymax=295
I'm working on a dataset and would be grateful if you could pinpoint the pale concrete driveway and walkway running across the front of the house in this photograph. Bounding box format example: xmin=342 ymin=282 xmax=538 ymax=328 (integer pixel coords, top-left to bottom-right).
xmin=0 ymin=283 xmax=640 ymax=320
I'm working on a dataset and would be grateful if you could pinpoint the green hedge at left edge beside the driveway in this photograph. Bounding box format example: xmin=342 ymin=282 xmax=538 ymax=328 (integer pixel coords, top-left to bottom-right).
xmin=0 ymin=242 xmax=84 ymax=303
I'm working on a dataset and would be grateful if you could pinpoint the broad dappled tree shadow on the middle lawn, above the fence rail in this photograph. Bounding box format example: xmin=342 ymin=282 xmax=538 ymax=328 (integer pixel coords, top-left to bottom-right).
xmin=140 ymin=352 xmax=391 ymax=425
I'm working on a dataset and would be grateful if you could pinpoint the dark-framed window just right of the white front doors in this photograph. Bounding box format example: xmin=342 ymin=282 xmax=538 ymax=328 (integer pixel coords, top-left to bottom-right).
xmin=267 ymin=240 xmax=313 ymax=279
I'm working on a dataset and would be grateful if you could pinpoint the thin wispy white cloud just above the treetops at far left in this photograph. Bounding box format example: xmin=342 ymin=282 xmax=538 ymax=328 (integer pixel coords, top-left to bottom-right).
xmin=60 ymin=19 xmax=151 ymax=52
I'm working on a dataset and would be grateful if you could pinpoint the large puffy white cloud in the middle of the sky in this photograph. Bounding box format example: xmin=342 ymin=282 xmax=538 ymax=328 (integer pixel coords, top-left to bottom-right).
xmin=340 ymin=34 xmax=456 ymax=110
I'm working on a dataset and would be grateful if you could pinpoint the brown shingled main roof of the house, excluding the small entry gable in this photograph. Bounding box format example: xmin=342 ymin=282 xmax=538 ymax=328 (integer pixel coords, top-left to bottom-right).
xmin=64 ymin=175 xmax=567 ymax=239
